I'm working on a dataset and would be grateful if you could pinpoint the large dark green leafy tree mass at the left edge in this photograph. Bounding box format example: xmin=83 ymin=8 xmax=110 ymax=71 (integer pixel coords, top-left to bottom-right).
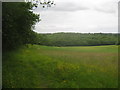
xmin=2 ymin=2 xmax=39 ymax=51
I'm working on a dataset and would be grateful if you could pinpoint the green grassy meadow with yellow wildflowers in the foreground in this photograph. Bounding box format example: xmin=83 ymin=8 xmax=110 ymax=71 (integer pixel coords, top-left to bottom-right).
xmin=3 ymin=45 xmax=118 ymax=88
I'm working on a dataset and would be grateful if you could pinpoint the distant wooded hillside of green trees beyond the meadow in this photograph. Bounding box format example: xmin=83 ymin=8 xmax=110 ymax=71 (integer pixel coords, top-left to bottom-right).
xmin=36 ymin=33 xmax=120 ymax=46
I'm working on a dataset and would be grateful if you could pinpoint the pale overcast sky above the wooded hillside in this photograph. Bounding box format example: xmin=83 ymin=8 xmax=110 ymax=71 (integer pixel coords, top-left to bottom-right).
xmin=34 ymin=0 xmax=119 ymax=33
